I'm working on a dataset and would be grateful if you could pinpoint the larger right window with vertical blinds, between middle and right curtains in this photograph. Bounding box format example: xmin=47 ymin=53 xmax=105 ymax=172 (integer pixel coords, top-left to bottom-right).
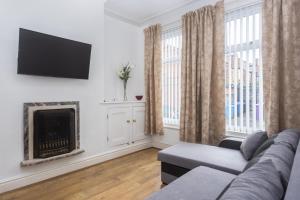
xmin=224 ymin=1 xmax=265 ymax=137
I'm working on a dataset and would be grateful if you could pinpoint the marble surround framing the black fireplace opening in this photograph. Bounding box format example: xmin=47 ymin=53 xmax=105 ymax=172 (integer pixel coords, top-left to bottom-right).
xmin=21 ymin=101 xmax=84 ymax=166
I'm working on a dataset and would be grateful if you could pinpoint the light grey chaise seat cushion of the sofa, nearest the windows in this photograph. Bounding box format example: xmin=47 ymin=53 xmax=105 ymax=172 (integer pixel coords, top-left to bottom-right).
xmin=158 ymin=142 xmax=247 ymax=175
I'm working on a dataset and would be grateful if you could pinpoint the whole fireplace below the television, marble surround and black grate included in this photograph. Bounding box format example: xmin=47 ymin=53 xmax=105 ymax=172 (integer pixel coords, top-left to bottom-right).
xmin=21 ymin=101 xmax=84 ymax=166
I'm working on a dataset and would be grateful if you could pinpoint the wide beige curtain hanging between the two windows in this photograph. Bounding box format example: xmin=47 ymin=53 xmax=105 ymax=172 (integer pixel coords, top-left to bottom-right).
xmin=180 ymin=1 xmax=225 ymax=144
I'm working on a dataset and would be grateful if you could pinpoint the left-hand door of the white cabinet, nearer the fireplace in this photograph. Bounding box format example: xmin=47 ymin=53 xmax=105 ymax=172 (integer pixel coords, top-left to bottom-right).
xmin=107 ymin=107 xmax=132 ymax=146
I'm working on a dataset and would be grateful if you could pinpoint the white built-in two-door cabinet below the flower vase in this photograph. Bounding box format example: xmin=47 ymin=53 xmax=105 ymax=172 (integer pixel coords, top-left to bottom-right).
xmin=105 ymin=102 xmax=147 ymax=146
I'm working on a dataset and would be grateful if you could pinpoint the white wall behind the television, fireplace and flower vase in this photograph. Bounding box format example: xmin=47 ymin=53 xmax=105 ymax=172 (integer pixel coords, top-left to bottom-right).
xmin=0 ymin=0 xmax=149 ymax=191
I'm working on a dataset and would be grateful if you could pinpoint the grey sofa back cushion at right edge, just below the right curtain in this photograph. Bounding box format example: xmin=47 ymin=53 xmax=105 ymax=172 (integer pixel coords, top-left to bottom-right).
xmin=274 ymin=129 xmax=300 ymax=152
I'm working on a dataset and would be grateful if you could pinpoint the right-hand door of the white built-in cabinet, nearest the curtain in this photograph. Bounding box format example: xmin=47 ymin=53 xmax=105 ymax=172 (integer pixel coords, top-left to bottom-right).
xmin=132 ymin=106 xmax=147 ymax=141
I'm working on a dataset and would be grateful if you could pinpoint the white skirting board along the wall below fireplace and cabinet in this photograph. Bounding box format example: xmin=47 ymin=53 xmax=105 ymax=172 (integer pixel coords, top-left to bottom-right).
xmin=0 ymin=142 xmax=151 ymax=194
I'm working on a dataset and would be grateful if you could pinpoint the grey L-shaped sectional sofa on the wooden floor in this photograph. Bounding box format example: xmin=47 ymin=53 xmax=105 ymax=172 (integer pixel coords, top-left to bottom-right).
xmin=148 ymin=129 xmax=300 ymax=200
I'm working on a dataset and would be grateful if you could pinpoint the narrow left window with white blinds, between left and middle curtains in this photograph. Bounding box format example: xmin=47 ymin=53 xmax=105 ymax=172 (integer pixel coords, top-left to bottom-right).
xmin=162 ymin=26 xmax=182 ymax=126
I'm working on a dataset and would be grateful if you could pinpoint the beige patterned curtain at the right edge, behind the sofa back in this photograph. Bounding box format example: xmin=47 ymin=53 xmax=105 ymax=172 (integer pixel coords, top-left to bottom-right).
xmin=262 ymin=0 xmax=300 ymax=134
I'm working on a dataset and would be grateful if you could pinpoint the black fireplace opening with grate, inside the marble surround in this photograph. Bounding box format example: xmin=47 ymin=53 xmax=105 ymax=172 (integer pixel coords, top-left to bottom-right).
xmin=33 ymin=109 xmax=75 ymax=158
